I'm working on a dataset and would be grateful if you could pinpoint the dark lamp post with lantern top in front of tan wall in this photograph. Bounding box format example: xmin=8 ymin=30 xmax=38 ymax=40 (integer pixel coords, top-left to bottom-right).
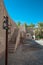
xmin=3 ymin=16 xmax=8 ymax=65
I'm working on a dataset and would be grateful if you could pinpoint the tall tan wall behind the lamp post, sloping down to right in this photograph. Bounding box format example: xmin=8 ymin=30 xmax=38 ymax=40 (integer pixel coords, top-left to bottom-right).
xmin=0 ymin=0 xmax=17 ymax=53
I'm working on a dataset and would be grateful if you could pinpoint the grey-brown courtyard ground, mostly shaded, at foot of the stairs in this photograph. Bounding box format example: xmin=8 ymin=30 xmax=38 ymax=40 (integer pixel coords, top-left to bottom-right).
xmin=0 ymin=40 xmax=43 ymax=65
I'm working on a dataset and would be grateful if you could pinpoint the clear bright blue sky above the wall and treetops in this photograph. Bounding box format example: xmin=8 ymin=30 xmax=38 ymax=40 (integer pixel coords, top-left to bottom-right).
xmin=4 ymin=0 xmax=43 ymax=24
